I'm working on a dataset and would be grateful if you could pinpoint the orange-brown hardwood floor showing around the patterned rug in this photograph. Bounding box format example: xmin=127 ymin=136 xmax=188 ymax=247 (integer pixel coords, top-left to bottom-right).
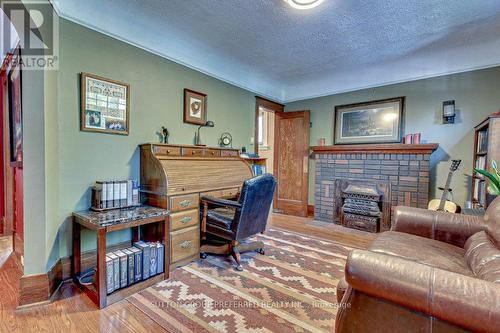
xmin=0 ymin=214 xmax=374 ymax=333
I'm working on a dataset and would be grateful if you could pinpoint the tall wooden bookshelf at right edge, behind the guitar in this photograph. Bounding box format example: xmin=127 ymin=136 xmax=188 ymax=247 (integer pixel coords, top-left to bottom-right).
xmin=471 ymin=111 xmax=500 ymax=208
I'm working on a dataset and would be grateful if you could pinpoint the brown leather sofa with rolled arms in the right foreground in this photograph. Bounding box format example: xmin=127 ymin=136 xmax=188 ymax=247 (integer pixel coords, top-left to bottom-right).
xmin=336 ymin=197 xmax=500 ymax=333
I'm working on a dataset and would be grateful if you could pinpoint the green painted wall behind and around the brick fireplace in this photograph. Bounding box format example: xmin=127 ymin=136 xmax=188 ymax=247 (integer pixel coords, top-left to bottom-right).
xmin=286 ymin=67 xmax=500 ymax=204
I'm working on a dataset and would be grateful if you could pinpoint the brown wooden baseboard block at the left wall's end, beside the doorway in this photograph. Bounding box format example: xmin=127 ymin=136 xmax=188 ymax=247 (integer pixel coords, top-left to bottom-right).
xmin=19 ymin=273 xmax=50 ymax=307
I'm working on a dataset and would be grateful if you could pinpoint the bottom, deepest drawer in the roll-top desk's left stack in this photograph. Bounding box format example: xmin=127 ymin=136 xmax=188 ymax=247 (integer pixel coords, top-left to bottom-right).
xmin=170 ymin=226 xmax=200 ymax=263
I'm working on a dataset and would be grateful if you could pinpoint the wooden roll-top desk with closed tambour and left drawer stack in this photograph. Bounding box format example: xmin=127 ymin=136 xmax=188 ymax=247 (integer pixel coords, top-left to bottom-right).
xmin=140 ymin=144 xmax=253 ymax=269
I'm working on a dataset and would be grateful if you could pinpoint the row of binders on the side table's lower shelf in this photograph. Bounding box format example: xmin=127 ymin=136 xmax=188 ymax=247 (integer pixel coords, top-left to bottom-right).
xmin=106 ymin=241 xmax=165 ymax=294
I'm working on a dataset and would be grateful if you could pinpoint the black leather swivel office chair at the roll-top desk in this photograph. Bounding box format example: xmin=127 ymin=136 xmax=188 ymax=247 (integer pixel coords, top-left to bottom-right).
xmin=201 ymin=174 xmax=276 ymax=271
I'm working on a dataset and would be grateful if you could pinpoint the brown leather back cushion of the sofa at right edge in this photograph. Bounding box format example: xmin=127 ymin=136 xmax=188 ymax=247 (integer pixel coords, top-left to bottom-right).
xmin=465 ymin=231 xmax=500 ymax=283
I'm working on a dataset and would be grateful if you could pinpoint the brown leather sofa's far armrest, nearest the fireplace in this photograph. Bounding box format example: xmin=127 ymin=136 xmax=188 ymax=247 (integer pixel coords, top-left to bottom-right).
xmin=391 ymin=206 xmax=485 ymax=248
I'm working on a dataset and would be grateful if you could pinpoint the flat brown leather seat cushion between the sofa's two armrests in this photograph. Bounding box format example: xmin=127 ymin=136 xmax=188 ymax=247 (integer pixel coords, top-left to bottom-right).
xmin=368 ymin=231 xmax=473 ymax=276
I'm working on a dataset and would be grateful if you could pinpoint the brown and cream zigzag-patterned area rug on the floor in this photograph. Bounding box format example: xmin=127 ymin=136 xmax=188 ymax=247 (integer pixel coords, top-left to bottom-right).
xmin=128 ymin=229 xmax=352 ymax=333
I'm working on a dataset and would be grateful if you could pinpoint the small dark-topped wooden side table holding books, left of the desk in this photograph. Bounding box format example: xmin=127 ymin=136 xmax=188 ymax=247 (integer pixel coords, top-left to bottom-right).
xmin=72 ymin=206 xmax=170 ymax=309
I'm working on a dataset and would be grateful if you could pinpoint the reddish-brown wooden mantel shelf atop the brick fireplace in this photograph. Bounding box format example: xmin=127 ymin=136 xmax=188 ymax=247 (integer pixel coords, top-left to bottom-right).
xmin=311 ymin=143 xmax=439 ymax=154
